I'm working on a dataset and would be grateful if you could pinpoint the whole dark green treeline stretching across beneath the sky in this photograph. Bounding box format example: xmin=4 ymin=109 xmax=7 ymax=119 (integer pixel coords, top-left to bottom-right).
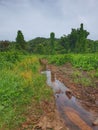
xmin=0 ymin=24 xmax=98 ymax=54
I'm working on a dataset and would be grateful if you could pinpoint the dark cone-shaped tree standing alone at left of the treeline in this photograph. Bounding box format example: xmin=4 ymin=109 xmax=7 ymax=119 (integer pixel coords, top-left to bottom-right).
xmin=16 ymin=30 xmax=26 ymax=49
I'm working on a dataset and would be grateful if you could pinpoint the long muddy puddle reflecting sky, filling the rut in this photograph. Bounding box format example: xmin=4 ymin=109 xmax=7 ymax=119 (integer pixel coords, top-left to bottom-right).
xmin=43 ymin=71 xmax=98 ymax=130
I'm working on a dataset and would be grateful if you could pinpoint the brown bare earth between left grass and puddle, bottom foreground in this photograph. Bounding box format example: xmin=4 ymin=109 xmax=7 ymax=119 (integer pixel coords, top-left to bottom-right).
xmin=18 ymin=98 xmax=68 ymax=130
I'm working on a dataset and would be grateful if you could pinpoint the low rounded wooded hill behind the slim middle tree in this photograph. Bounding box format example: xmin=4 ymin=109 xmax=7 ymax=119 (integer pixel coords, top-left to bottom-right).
xmin=28 ymin=37 xmax=62 ymax=55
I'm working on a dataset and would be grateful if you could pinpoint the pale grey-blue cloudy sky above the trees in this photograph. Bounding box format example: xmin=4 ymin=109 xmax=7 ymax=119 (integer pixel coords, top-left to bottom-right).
xmin=0 ymin=0 xmax=98 ymax=40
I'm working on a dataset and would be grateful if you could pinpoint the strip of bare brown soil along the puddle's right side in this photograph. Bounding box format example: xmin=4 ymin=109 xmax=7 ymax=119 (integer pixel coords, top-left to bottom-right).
xmin=47 ymin=63 xmax=98 ymax=113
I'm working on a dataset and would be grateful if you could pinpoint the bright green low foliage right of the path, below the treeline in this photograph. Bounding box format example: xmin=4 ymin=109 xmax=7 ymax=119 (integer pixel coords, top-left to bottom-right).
xmin=47 ymin=53 xmax=98 ymax=70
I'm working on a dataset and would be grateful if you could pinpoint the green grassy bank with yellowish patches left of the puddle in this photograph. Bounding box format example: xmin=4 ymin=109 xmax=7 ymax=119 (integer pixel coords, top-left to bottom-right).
xmin=0 ymin=52 xmax=52 ymax=130
